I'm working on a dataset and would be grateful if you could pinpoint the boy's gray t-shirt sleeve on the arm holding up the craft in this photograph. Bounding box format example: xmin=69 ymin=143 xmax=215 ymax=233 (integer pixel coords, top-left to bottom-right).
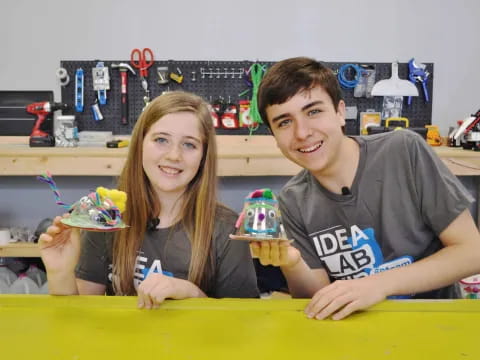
xmin=278 ymin=189 xmax=324 ymax=269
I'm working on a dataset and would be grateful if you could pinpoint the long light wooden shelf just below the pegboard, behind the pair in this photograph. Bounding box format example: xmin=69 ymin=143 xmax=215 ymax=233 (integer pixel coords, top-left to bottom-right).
xmin=0 ymin=135 xmax=480 ymax=176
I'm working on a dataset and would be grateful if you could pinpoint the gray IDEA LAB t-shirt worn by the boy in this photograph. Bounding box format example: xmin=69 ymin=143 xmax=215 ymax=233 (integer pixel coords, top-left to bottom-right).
xmin=279 ymin=130 xmax=473 ymax=298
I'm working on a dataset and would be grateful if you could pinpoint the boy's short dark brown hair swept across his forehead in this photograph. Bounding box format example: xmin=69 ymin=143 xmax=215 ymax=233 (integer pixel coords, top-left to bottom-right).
xmin=257 ymin=57 xmax=343 ymax=130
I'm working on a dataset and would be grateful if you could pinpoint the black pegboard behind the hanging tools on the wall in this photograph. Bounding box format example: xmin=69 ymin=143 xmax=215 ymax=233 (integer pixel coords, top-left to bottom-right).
xmin=60 ymin=60 xmax=433 ymax=135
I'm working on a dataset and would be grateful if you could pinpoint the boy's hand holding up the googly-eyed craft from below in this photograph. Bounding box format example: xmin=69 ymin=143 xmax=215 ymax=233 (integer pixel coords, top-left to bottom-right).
xmin=250 ymin=240 xmax=301 ymax=268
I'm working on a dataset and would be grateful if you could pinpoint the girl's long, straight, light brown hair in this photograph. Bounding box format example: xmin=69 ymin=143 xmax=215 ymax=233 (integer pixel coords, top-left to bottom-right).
xmin=112 ymin=91 xmax=217 ymax=295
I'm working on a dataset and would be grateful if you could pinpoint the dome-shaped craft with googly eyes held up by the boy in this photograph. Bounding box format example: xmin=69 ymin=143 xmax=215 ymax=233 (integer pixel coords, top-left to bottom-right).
xmin=230 ymin=188 xmax=289 ymax=241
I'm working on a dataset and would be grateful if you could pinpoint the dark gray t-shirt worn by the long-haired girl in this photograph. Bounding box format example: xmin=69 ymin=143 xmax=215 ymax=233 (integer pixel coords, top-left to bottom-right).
xmin=75 ymin=207 xmax=259 ymax=298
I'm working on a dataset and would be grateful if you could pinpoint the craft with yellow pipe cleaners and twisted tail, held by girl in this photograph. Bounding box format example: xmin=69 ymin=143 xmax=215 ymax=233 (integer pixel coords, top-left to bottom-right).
xmin=37 ymin=171 xmax=127 ymax=231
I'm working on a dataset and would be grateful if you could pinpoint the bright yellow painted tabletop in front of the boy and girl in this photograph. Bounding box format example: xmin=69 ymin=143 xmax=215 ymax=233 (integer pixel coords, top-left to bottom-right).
xmin=0 ymin=295 xmax=480 ymax=360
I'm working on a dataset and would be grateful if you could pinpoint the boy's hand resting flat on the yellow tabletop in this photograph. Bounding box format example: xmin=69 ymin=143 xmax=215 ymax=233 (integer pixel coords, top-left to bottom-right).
xmin=305 ymin=276 xmax=386 ymax=320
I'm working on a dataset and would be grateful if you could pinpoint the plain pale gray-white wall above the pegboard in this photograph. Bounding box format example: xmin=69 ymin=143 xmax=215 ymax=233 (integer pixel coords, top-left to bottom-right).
xmin=0 ymin=0 xmax=480 ymax=134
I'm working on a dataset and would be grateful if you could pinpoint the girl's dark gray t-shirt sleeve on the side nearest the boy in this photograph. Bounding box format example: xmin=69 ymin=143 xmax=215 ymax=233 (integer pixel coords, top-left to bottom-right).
xmin=211 ymin=208 xmax=259 ymax=298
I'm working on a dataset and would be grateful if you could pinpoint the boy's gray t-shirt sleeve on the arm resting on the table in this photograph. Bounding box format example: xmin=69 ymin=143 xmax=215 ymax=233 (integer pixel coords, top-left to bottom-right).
xmin=407 ymin=134 xmax=474 ymax=235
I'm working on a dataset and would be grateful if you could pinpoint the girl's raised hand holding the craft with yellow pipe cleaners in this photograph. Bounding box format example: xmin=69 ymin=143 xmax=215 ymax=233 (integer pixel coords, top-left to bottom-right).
xmin=38 ymin=214 xmax=80 ymax=274
